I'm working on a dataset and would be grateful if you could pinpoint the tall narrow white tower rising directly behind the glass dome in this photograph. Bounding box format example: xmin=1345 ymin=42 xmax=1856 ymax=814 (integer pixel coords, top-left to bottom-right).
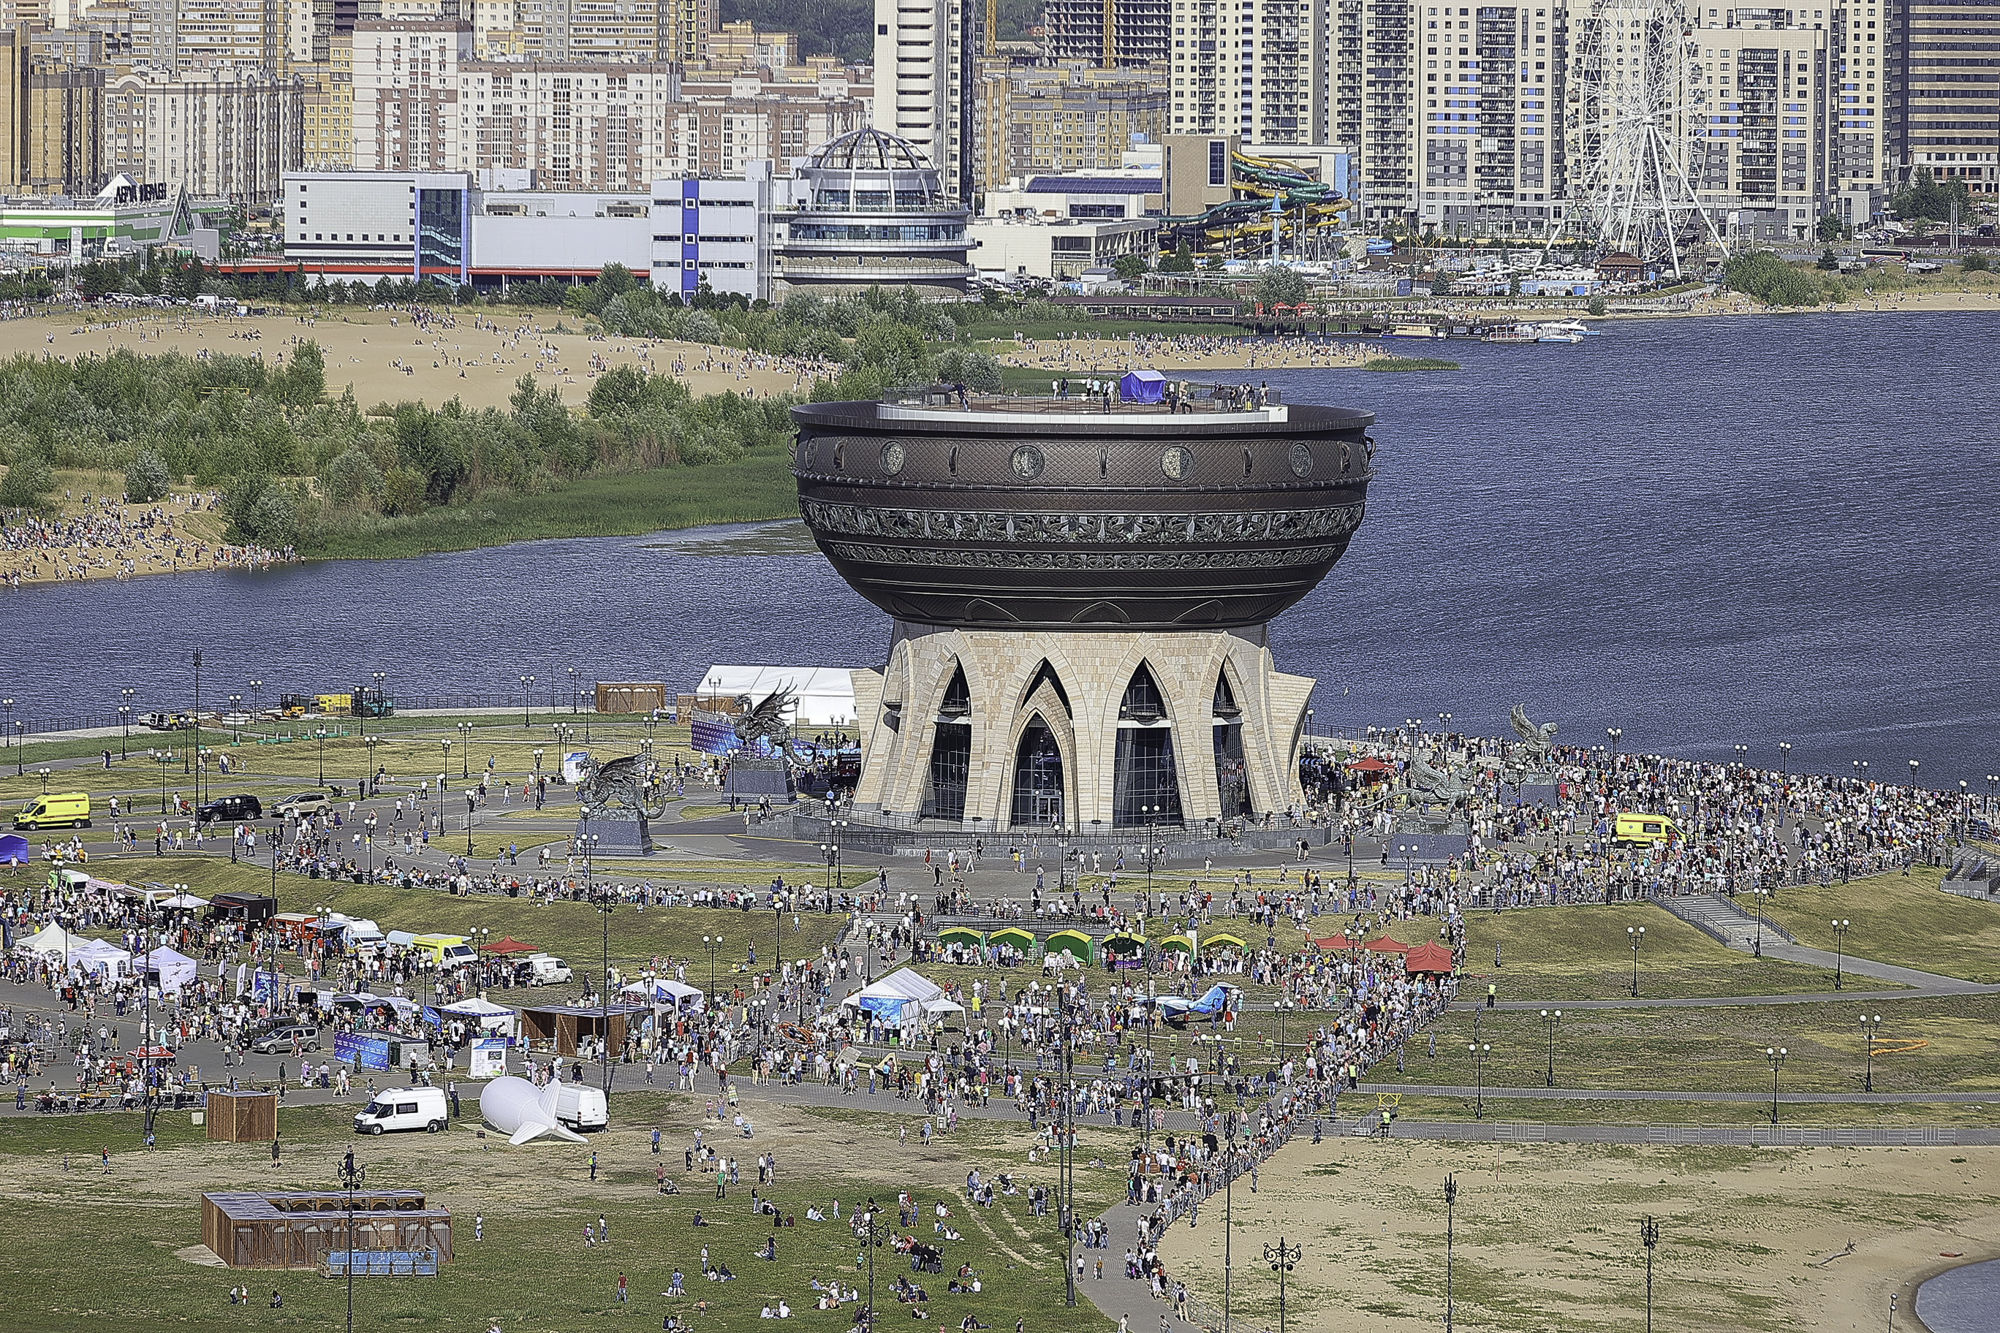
xmin=874 ymin=0 xmax=986 ymax=202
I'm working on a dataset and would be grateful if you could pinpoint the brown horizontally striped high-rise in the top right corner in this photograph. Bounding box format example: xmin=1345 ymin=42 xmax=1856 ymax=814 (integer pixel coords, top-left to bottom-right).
xmin=1888 ymin=0 xmax=2000 ymax=194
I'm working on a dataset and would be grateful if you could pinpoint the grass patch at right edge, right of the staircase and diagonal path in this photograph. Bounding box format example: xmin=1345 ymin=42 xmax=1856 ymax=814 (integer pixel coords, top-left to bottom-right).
xmin=1760 ymin=867 xmax=2000 ymax=983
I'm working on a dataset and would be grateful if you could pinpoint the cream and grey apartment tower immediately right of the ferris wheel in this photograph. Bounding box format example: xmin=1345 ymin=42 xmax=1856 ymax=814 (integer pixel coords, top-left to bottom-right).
xmin=1688 ymin=8 xmax=1842 ymax=240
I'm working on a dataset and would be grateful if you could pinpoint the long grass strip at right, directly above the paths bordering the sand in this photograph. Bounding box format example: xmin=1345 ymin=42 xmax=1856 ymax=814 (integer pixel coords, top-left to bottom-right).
xmin=1370 ymin=995 xmax=2000 ymax=1107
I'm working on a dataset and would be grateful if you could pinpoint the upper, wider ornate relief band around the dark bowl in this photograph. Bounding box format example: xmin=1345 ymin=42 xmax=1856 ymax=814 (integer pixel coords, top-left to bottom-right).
xmin=800 ymin=500 xmax=1366 ymax=544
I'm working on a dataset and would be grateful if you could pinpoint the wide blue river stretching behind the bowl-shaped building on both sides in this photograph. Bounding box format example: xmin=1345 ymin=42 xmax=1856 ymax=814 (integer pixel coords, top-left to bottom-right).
xmin=0 ymin=314 xmax=2000 ymax=791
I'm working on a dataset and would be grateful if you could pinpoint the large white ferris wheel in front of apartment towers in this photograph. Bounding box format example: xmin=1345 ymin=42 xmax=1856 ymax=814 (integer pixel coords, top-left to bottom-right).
xmin=1572 ymin=0 xmax=1728 ymax=278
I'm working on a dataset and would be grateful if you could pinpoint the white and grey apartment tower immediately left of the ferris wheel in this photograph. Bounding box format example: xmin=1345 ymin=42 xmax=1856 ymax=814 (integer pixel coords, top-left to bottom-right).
xmin=1416 ymin=0 xmax=1568 ymax=234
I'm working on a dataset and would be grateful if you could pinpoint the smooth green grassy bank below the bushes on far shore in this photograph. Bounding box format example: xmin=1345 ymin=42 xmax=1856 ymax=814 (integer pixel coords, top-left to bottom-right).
xmin=306 ymin=448 xmax=798 ymax=558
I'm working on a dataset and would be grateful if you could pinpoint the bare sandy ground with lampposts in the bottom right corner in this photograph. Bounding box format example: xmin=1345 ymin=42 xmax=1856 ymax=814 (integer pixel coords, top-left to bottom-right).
xmin=1162 ymin=1137 xmax=2000 ymax=1333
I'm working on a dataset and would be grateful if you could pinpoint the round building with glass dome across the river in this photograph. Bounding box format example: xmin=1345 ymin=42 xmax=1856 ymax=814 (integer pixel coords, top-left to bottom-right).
xmin=776 ymin=128 xmax=974 ymax=298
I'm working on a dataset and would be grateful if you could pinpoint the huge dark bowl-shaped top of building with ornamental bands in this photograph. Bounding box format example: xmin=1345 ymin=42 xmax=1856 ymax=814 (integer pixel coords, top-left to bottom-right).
xmin=792 ymin=400 xmax=1374 ymax=630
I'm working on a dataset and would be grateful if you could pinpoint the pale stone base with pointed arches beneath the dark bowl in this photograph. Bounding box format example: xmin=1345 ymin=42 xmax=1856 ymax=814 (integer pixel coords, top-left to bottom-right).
xmin=852 ymin=622 xmax=1312 ymax=835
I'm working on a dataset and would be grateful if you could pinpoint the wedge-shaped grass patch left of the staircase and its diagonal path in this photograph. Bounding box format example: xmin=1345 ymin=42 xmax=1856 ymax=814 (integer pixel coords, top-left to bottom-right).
xmin=1448 ymin=895 xmax=1848 ymax=1001
